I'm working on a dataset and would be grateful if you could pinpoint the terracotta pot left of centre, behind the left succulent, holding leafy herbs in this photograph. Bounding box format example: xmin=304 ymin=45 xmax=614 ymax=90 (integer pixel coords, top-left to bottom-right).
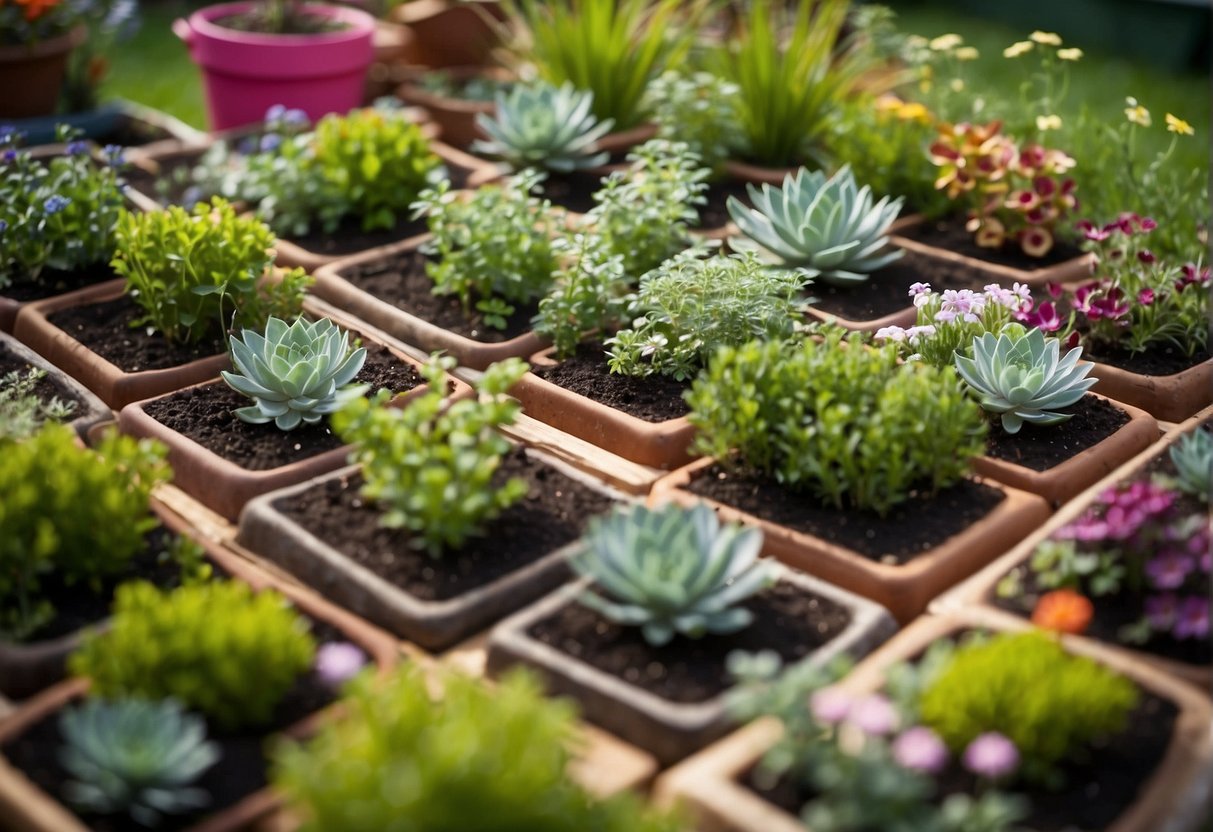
xmin=312 ymin=234 xmax=543 ymax=370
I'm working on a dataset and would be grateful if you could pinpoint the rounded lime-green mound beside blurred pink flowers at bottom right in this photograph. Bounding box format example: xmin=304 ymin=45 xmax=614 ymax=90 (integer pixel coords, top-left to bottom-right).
xmin=921 ymin=632 xmax=1138 ymax=780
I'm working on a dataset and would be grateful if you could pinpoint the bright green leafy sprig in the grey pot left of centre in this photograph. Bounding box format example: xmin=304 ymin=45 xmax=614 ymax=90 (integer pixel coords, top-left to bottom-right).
xmin=332 ymin=358 xmax=528 ymax=557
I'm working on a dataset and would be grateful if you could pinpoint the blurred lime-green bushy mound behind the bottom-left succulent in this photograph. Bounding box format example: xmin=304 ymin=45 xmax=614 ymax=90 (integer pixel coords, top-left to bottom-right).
xmin=68 ymin=581 xmax=315 ymax=729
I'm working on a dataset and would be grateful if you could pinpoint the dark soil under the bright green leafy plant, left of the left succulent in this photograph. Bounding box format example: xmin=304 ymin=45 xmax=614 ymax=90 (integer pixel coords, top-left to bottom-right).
xmin=47 ymin=295 xmax=226 ymax=372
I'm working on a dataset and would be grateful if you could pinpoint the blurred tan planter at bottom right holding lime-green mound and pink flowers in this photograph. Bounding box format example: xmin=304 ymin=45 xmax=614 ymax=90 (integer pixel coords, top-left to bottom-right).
xmin=655 ymin=617 xmax=1213 ymax=832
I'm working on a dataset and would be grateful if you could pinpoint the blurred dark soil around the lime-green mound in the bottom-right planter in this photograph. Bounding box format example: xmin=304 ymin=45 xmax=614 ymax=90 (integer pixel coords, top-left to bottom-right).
xmin=744 ymin=690 xmax=1179 ymax=832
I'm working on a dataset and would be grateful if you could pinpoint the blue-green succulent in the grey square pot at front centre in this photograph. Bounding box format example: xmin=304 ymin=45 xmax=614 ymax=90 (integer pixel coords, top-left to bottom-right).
xmin=573 ymin=503 xmax=775 ymax=646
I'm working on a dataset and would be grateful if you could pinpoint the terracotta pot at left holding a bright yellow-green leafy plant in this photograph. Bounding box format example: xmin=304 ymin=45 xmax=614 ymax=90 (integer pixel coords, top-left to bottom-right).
xmin=13 ymin=280 xmax=228 ymax=410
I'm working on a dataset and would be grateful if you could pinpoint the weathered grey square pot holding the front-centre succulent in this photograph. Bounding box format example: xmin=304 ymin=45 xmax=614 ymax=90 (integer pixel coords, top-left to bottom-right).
xmin=488 ymin=569 xmax=896 ymax=765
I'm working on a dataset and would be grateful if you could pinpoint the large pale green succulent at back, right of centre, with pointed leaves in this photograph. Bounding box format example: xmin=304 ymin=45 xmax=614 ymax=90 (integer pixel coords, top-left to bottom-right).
xmin=729 ymin=165 xmax=902 ymax=285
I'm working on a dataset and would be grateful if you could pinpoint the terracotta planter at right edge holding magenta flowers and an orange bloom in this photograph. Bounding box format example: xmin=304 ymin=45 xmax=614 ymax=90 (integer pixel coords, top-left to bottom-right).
xmin=930 ymin=408 xmax=1213 ymax=690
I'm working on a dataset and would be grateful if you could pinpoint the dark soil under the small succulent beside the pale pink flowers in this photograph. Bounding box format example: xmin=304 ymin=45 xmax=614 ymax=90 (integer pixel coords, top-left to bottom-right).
xmin=986 ymin=394 xmax=1129 ymax=471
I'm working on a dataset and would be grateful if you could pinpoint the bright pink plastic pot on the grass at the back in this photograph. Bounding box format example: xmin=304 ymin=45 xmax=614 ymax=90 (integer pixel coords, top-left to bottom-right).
xmin=172 ymin=2 xmax=375 ymax=130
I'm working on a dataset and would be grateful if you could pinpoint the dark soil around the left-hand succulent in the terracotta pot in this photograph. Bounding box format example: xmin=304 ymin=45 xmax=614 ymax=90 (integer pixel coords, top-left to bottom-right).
xmin=143 ymin=343 xmax=423 ymax=471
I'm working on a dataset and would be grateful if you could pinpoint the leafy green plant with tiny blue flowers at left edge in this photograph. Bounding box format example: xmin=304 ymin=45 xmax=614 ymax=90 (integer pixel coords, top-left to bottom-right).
xmin=0 ymin=127 xmax=124 ymax=289
